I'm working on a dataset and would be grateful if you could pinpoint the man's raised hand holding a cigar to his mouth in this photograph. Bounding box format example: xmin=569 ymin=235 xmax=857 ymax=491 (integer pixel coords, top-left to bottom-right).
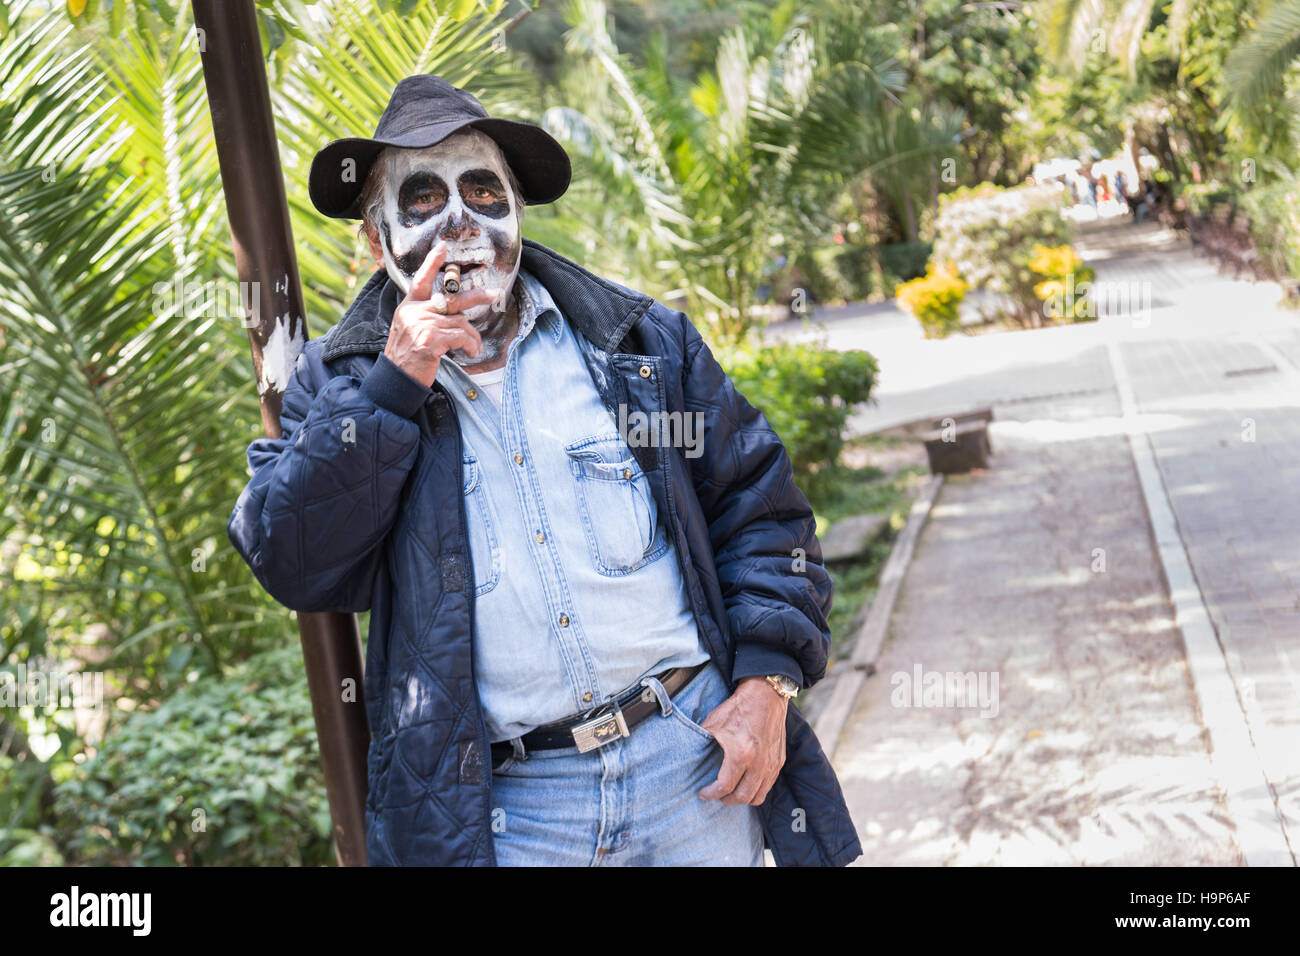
xmin=384 ymin=242 xmax=498 ymax=388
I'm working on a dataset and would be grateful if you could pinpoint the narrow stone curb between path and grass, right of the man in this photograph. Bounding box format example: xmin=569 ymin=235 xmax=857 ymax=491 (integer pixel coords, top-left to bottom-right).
xmin=813 ymin=475 xmax=944 ymax=760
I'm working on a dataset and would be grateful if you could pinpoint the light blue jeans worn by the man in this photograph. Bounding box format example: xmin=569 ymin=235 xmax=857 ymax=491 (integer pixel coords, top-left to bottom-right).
xmin=491 ymin=662 xmax=763 ymax=866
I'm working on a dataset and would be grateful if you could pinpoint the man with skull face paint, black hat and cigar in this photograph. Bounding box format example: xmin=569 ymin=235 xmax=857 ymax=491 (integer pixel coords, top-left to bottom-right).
xmin=229 ymin=75 xmax=861 ymax=865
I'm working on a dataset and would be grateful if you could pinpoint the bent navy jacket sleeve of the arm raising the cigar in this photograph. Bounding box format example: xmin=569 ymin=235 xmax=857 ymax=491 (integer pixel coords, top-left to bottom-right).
xmin=226 ymin=342 xmax=432 ymax=611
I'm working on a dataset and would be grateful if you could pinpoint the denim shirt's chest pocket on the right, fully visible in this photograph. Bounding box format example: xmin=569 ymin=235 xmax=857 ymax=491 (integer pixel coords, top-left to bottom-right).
xmin=564 ymin=434 xmax=668 ymax=578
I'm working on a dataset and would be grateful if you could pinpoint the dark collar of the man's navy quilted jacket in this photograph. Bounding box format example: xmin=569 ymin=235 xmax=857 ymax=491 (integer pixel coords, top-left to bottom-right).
xmin=321 ymin=238 xmax=654 ymax=362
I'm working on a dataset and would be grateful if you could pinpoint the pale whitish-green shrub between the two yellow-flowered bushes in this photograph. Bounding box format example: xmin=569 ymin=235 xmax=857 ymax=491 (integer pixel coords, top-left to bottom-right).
xmin=935 ymin=182 xmax=1071 ymax=326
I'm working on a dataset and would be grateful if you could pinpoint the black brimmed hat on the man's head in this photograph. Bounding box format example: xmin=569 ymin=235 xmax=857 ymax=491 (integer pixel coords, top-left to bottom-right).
xmin=307 ymin=74 xmax=572 ymax=219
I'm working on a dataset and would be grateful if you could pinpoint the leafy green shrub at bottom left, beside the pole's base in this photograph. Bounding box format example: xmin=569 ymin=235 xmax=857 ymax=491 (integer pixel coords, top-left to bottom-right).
xmin=55 ymin=641 xmax=330 ymax=865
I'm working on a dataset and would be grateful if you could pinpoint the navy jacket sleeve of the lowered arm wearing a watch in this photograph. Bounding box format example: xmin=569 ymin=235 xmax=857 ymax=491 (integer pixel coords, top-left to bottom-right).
xmin=683 ymin=316 xmax=832 ymax=687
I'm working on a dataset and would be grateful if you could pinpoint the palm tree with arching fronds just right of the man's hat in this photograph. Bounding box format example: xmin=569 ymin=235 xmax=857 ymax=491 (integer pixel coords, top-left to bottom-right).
xmin=545 ymin=0 xmax=957 ymax=339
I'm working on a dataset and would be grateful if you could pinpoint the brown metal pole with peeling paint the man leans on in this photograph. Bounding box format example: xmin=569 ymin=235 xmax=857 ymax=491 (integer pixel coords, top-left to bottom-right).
xmin=194 ymin=0 xmax=371 ymax=866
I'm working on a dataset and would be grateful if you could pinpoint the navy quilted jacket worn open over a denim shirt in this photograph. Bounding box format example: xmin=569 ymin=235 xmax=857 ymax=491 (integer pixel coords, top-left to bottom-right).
xmin=228 ymin=239 xmax=862 ymax=866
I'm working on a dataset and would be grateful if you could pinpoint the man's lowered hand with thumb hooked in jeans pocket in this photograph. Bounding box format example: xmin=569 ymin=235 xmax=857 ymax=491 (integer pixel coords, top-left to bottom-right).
xmin=699 ymin=678 xmax=789 ymax=806
